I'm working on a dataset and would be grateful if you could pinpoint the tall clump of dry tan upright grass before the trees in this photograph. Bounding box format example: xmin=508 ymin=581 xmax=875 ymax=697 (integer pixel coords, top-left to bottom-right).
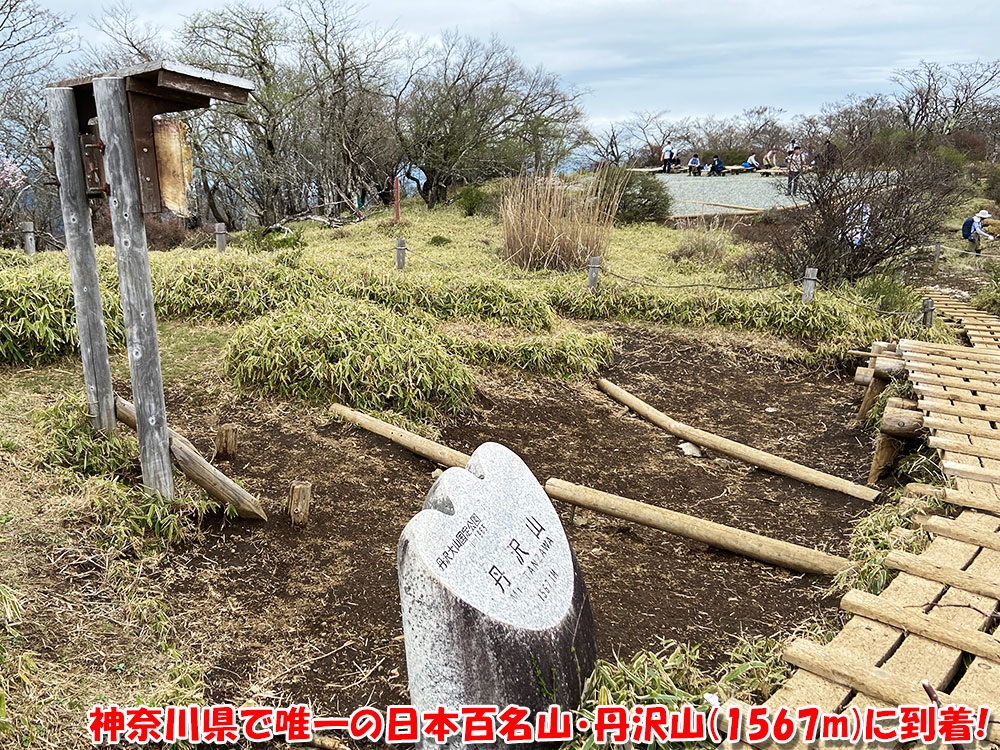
xmin=500 ymin=169 xmax=628 ymax=271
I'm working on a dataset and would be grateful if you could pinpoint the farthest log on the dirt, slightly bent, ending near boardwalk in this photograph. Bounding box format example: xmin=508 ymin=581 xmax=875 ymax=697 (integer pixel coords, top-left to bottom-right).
xmin=597 ymin=378 xmax=881 ymax=501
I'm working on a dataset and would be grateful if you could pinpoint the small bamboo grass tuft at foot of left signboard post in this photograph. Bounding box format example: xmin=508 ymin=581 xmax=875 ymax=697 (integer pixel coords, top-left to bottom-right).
xmin=32 ymin=394 xmax=139 ymax=479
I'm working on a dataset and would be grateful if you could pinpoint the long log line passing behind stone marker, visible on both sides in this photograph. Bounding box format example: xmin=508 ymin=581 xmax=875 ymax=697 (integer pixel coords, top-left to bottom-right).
xmin=333 ymin=404 xmax=850 ymax=575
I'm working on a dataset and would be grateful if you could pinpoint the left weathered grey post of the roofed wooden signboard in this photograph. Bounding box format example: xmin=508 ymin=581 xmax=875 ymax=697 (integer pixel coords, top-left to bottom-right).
xmin=45 ymin=88 xmax=116 ymax=433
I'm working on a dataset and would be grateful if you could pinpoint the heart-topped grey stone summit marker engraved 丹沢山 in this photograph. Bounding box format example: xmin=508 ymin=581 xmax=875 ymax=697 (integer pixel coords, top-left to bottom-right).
xmin=397 ymin=443 xmax=597 ymax=746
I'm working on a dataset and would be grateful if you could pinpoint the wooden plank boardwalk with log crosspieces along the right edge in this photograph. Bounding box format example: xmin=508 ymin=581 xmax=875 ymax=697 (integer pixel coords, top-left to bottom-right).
xmin=728 ymin=294 xmax=1000 ymax=748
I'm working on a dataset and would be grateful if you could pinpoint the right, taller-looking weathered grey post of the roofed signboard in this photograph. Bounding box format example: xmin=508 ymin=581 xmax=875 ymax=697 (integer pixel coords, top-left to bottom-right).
xmin=94 ymin=77 xmax=174 ymax=498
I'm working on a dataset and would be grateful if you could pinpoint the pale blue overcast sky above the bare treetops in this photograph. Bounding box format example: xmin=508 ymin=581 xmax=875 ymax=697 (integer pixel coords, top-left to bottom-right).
xmin=52 ymin=0 xmax=1000 ymax=123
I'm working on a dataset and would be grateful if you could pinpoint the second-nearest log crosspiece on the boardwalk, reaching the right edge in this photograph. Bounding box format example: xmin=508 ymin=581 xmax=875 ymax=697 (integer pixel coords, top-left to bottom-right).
xmin=840 ymin=589 xmax=1000 ymax=661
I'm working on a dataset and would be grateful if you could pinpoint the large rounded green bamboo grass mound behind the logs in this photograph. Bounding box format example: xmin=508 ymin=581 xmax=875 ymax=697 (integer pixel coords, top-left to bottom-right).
xmin=225 ymin=296 xmax=473 ymax=417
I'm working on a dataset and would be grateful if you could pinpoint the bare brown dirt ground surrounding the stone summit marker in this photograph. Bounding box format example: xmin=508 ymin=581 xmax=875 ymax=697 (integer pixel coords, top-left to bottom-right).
xmin=150 ymin=324 xmax=871 ymax=724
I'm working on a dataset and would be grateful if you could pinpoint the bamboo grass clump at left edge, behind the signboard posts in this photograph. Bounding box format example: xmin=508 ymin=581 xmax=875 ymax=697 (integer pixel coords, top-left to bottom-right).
xmin=0 ymin=263 xmax=125 ymax=365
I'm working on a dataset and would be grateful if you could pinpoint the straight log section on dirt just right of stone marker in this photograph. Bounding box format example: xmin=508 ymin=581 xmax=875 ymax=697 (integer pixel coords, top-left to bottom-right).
xmin=545 ymin=479 xmax=851 ymax=575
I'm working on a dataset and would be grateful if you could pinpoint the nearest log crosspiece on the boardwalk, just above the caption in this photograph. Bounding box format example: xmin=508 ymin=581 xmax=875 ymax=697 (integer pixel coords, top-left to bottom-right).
xmin=782 ymin=638 xmax=1000 ymax=742
